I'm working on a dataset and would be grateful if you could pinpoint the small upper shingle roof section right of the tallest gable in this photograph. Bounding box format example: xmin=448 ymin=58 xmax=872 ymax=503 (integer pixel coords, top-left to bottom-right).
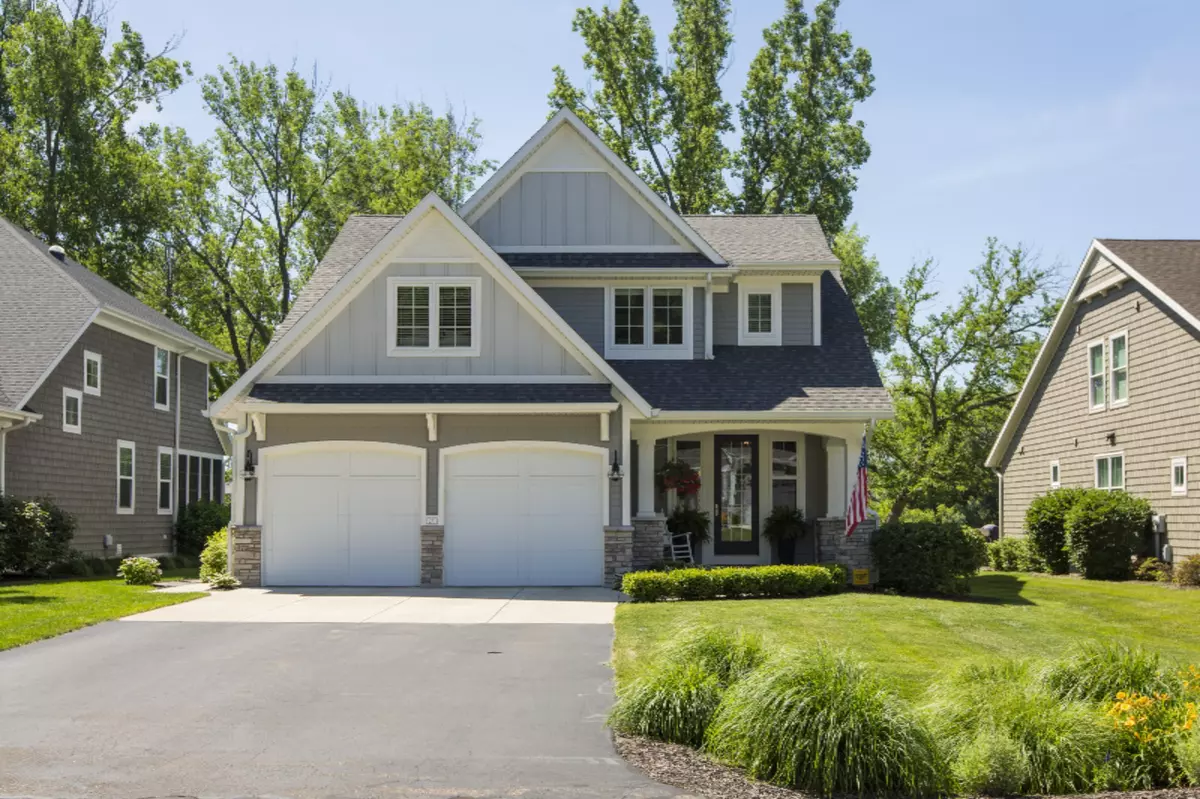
xmin=683 ymin=214 xmax=838 ymax=266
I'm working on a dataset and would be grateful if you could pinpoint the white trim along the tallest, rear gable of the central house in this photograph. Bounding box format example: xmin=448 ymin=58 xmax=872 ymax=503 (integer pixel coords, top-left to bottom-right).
xmin=462 ymin=108 xmax=725 ymax=264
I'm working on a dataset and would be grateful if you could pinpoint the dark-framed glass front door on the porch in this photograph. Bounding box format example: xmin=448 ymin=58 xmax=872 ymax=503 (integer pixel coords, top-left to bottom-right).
xmin=713 ymin=435 xmax=758 ymax=554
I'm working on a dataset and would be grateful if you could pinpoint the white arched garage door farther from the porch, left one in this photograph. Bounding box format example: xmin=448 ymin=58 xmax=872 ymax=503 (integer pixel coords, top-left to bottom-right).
xmin=263 ymin=441 xmax=424 ymax=585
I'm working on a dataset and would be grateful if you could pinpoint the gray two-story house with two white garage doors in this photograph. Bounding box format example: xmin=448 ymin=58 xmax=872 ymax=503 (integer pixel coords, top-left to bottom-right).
xmin=211 ymin=112 xmax=892 ymax=585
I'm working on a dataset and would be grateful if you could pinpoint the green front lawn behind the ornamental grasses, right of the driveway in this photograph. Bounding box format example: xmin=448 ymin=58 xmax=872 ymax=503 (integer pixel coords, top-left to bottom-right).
xmin=614 ymin=573 xmax=1200 ymax=697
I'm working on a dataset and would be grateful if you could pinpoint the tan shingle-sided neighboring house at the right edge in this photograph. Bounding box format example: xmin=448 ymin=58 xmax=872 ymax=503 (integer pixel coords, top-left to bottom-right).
xmin=988 ymin=239 xmax=1200 ymax=559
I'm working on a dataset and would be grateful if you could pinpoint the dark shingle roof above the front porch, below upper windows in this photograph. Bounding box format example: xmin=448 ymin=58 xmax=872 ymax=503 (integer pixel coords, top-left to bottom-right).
xmin=610 ymin=272 xmax=892 ymax=413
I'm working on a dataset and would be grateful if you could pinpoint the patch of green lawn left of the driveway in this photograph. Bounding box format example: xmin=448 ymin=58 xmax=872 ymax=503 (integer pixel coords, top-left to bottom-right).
xmin=0 ymin=578 xmax=203 ymax=650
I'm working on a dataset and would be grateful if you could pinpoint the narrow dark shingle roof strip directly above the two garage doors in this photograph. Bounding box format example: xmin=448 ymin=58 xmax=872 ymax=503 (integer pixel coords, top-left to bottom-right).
xmin=250 ymin=383 xmax=613 ymax=404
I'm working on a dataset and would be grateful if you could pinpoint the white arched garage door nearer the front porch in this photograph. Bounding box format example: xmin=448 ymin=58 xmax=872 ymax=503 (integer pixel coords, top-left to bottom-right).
xmin=443 ymin=445 xmax=606 ymax=585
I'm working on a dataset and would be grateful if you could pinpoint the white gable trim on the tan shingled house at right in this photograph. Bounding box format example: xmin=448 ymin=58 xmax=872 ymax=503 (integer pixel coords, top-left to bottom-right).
xmin=985 ymin=239 xmax=1200 ymax=469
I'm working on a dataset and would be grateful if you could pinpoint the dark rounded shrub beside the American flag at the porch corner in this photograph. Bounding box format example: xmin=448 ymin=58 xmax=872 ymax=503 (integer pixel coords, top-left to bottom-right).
xmin=871 ymin=522 xmax=988 ymax=595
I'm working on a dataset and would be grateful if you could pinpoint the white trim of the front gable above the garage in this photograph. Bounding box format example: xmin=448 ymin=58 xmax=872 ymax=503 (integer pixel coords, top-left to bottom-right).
xmin=209 ymin=192 xmax=653 ymax=417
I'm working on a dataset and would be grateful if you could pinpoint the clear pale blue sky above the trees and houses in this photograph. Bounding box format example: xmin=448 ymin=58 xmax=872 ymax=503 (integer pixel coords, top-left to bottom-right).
xmin=112 ymin=0 xmax=1200 ymax=290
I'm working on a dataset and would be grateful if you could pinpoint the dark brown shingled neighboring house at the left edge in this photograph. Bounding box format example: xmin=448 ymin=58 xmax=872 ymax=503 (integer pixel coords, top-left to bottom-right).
xmin=0 ymin=220 xmax=228 ymax=557
